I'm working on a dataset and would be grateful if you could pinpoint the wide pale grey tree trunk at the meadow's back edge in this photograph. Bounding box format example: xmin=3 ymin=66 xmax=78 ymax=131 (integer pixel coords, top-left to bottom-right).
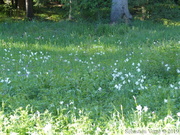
xmin=111 ymin=0 xmax=132 ymax=23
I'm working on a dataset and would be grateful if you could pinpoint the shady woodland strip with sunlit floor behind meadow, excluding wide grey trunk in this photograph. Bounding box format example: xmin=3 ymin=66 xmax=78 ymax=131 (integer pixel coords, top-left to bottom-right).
xmin=0 ymin=0 xmax=180 ymax=22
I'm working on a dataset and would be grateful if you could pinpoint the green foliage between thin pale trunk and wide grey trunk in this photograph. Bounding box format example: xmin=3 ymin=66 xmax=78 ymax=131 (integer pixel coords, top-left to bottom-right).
xmin=59 ymin=0 xmax=111 ymax=21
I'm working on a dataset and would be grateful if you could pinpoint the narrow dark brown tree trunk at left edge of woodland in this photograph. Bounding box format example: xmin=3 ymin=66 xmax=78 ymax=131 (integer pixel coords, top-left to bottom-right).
xmin=26 ymin=0 xmax=34 ymax=20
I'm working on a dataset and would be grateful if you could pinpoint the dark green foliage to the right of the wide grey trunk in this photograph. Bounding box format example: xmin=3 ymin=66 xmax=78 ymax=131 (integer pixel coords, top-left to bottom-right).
xmin=129 ymin=0 xmax=180 ymax=20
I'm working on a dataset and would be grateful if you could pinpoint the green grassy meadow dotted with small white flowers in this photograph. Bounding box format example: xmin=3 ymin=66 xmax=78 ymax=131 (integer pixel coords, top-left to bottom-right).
xmin=0 ymin=21 xmax=180 ymax=135
